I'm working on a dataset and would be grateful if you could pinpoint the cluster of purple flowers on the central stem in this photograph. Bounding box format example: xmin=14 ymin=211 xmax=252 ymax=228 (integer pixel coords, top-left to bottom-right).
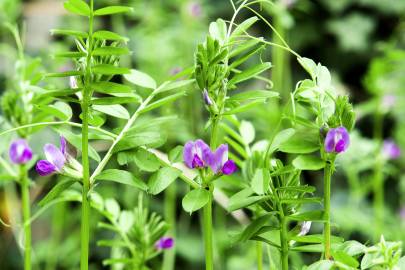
xmin=183 ymin=140 xmax=237 ymax=175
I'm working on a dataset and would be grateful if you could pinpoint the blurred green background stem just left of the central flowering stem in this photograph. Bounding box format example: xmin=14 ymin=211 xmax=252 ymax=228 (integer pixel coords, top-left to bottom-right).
xmin=162 ymin=182 xmax=176 ymax=270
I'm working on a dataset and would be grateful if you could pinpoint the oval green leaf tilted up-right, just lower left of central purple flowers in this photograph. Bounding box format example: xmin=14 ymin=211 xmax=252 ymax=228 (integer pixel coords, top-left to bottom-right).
xmin=148 ymin=167 xmax=182 ymax=195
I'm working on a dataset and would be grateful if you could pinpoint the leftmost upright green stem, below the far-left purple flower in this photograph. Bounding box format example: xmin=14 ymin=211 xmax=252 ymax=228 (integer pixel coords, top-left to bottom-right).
xmin=20 ymin=165 xmax=31 ymax=270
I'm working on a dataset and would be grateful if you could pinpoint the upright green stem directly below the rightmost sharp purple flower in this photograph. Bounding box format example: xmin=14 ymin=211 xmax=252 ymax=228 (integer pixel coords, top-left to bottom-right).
xmin=323 ymin=160 xmax=334 ymax=260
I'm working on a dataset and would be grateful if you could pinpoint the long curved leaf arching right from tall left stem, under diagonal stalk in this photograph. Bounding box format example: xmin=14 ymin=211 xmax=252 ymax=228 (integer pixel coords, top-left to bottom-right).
xmin=96 ymin=169 xmax=148 ymax=191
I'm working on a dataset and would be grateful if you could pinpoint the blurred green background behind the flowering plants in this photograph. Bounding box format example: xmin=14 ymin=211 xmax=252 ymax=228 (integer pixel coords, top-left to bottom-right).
xmin=0 ymin=0 xmax=405 ymax=270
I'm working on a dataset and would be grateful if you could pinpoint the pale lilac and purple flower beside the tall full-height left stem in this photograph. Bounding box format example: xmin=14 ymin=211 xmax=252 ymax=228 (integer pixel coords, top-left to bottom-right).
xmin=36 ymin=137 xmax=67 ymax=176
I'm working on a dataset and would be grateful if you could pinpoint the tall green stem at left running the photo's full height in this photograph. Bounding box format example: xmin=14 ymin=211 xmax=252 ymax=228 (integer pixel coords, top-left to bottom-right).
xmin=80 ymin=0 xmax=94 ymax=270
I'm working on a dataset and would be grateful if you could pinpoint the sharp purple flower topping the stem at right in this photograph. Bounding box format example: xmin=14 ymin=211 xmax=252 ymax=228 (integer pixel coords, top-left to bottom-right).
xmin=325 ymin=127 xmax=350 ymax=153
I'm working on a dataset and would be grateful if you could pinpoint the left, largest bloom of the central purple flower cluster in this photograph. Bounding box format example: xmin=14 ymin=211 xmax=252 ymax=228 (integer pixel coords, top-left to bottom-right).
xmin=183 ymin=140 xmax=211 ymax=169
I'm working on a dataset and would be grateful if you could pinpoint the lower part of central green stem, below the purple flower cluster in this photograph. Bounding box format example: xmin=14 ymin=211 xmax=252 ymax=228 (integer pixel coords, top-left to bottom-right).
xmin=203 ymin=192 xmax=214 ymax=270
